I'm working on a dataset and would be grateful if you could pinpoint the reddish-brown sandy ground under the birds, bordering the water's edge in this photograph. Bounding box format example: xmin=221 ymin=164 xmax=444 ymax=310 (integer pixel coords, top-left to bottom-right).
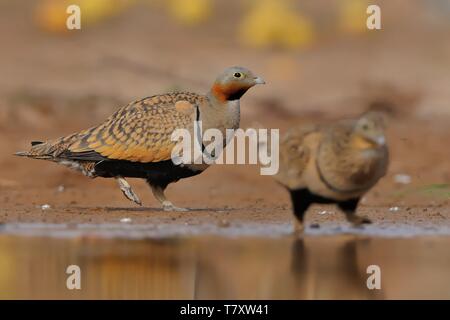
xmin=0 ymin=116 xmax=450 ymax=236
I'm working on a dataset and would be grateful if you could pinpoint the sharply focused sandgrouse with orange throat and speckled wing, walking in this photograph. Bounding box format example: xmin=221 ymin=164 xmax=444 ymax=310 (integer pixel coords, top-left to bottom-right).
xmin=16 ymin=67 xmax=264 ymax=211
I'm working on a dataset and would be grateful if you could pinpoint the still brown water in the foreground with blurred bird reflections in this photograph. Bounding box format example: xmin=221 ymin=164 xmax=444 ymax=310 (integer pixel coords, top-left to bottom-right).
xmin=0 ymin=235 xmax=450 ymax=299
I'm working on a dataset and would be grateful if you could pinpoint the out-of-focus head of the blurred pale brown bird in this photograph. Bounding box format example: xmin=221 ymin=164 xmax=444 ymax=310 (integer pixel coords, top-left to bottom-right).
xmin=353 ymin=112 xmax=386 ymax=149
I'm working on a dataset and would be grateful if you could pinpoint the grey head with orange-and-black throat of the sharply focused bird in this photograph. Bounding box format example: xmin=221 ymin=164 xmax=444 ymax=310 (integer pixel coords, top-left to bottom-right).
xmin=211 ymin=67 xmax=265 ymax=102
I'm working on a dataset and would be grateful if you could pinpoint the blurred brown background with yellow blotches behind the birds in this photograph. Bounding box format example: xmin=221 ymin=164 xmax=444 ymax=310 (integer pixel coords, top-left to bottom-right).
xmin=0 ymin=0 xmax=450 ymax=128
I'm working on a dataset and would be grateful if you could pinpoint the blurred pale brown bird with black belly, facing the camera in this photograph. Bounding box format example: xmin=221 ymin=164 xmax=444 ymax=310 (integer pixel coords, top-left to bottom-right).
xmin=275 ymin=112 xmax=388 ymax=230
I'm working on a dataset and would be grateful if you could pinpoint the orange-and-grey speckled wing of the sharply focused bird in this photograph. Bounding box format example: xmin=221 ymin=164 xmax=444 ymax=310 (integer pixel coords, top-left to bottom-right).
xmin=61 ymin=94 xmax=202 ymax=163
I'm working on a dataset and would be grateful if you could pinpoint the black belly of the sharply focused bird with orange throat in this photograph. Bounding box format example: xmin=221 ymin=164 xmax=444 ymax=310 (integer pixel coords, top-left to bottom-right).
xmin=95 ymin=160 xmax=202 ymax=185
